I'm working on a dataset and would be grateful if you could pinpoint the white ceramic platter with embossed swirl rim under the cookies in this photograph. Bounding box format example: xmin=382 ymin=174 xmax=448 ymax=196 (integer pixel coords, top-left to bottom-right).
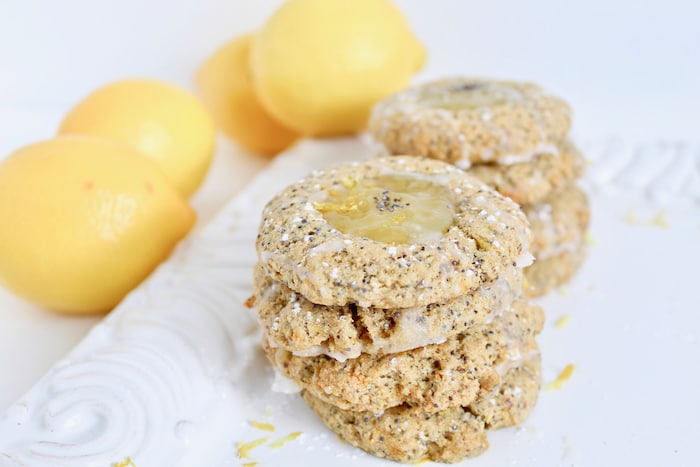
xmin=0 ymin=140 xmax=700 ymax=467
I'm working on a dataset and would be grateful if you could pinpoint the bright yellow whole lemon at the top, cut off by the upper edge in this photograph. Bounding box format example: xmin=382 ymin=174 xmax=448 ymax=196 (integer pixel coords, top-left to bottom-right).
xmin=250 ymin=0 xmax=425 ymax=135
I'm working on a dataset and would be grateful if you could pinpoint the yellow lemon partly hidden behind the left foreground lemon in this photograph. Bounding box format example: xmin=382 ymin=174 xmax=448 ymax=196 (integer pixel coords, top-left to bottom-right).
xmin=58 ymin=79 xmax=216 ymax=197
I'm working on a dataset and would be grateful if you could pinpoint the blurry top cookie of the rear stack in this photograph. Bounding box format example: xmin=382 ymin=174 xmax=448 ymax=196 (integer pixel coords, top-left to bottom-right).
xmin=369 ymin=78 xmax=571 ymax=167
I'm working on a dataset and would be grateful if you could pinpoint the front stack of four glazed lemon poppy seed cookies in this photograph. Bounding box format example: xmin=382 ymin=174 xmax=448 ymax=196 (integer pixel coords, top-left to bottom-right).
xmin=251 ymin=156 xmax=543 ymax=462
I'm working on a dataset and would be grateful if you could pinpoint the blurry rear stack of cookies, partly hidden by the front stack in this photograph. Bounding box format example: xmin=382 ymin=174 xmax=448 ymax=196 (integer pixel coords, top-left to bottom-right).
xmin=369 ymin=78 xmax=589 ymax=297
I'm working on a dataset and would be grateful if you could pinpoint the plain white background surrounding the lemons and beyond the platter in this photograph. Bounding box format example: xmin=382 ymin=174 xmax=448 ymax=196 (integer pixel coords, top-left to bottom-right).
xmin=0 ymin=0 xmax=700 ymax=429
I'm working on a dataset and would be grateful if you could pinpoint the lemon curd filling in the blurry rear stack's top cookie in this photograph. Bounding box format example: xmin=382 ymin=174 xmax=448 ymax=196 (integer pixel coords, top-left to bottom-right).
xmin=421 ymin=83 xmax=521 ymax=112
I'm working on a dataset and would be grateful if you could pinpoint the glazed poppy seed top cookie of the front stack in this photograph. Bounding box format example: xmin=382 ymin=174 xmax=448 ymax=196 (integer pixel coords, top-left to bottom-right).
xmin=256 ymin=156 xmax=530 ymax=308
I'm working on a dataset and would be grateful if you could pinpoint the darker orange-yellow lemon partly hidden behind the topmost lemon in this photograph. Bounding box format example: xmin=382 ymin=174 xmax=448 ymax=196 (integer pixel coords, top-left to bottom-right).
xmin=196 ymin=34 xmax=299 ymax=155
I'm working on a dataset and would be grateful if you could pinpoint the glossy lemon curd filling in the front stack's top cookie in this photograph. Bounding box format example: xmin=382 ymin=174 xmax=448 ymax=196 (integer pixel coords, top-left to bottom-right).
xmin=314 ymin=174 xmax=455 ymax=244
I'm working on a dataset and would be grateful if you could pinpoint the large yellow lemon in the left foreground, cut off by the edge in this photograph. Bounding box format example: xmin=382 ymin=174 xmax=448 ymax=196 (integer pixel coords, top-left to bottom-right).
xmin=0 ymin=137 xmax=195 ymax=313
